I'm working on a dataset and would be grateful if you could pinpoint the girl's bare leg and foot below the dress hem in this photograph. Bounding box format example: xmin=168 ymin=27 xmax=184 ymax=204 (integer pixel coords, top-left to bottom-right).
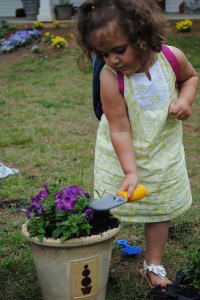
xmin=145 ymin=221 xmax=172 ymax=288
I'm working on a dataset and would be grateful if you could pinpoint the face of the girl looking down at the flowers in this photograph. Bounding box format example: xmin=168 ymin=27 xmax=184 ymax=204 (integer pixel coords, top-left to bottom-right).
xmin=92 ymin=23 xmax=141 ymax=76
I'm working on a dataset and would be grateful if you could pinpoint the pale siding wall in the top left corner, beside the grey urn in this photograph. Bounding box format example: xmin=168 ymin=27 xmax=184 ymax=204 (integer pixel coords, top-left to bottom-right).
xmin=0 ymin=0 xmax=23 ymax=17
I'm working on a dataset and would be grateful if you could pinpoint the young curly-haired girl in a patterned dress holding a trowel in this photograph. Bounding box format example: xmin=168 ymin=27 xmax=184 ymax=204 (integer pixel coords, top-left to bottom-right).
xmin=78 ymin=0 xmax=198 ymax=288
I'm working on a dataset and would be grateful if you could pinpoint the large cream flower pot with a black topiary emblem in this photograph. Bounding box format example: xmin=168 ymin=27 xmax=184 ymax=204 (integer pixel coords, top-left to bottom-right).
xmin=22 ymin=224 xmax=120 ymax=300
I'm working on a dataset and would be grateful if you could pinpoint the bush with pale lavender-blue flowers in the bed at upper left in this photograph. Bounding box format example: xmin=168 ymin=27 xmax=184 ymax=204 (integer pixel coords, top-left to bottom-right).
xmin=0 ymin=29 xmax=41 ymax=54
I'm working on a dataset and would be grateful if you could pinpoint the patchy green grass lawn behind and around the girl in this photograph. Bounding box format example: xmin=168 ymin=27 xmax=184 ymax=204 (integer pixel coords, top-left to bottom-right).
xmin=0 ymin=30 xmax=200 ymax=300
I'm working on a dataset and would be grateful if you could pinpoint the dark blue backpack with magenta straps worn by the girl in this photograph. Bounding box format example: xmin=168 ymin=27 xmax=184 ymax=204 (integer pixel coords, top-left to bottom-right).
xmin=92 ymin=44 xmax=180 ymax=121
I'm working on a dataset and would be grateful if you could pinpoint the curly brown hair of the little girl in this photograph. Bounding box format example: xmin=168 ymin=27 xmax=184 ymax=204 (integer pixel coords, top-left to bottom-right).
xmin=77 ymin=0 xmax=167 ymax=70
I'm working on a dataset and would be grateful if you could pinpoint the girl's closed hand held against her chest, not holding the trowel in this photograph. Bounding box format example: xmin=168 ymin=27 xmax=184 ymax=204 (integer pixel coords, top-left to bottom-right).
xmin=168 ymin=97 xmax=191 ymax=121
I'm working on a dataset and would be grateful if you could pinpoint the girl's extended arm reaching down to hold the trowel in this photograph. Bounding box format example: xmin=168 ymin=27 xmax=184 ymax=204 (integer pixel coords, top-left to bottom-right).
xmin=100 ymin=69 xmax=137 ymax=198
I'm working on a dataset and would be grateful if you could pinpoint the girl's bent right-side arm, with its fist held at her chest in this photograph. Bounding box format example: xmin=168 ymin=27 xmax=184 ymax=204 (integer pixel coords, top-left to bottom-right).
xmin=169 ymin=47 xmax=198 ymax=121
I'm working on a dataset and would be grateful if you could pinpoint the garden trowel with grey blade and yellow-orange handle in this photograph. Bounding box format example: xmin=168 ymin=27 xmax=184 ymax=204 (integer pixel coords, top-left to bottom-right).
xmin=88 ymin=185 xmax=147 ymax=211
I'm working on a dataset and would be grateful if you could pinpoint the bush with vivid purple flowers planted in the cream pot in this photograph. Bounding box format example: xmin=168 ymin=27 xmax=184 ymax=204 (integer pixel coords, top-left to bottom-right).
xmin=26 ymin=184 xmax=93 ymax=242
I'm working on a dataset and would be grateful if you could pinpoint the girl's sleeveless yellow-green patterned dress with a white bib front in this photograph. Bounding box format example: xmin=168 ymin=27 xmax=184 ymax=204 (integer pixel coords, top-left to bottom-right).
xmin=94 ymin=52 xmax=192 ymax=222
